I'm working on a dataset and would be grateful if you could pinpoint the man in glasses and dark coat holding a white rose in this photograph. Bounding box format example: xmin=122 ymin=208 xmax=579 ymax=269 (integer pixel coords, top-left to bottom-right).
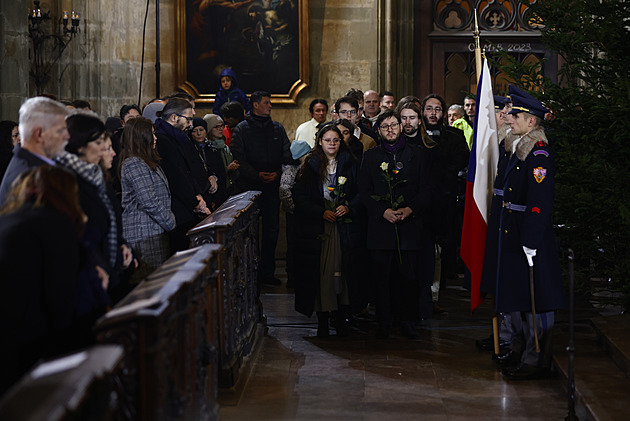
xmin=359 ymin=110 xmax=434 ymax=339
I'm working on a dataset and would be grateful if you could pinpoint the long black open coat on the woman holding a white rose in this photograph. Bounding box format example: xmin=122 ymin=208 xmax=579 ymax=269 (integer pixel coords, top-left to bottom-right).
xmin=293 ymin=150 xmax=363 ymax=316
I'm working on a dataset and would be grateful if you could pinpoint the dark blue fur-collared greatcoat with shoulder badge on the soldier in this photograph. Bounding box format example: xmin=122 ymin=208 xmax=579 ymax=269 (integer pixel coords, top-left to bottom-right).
xmin=481 ymin=128 xmax=565 ymax=312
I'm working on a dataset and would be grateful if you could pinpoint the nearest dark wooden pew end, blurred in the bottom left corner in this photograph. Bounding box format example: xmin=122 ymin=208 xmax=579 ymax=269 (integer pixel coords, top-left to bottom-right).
xmin=0 ymin=345 xmax=124 ymax=421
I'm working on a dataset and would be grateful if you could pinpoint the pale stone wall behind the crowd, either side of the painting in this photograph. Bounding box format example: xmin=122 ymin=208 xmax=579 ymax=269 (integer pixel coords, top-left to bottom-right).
xmin=0 ymin=0 xmax=392 ymax=138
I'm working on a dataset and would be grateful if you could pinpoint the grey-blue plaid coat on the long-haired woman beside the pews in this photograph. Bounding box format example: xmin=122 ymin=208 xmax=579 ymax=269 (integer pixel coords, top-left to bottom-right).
xmin=120 ymin=157 xmax=175 ymax=269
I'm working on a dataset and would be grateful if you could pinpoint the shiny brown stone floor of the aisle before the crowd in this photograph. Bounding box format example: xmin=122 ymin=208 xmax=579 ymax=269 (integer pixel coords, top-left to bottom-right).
xmin=221 ymin=276 xmax=567 ymax=421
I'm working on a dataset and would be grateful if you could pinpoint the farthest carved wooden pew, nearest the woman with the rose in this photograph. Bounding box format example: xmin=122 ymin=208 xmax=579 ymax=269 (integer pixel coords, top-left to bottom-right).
xmin=188 ymin=191 xmax=262 ymax=394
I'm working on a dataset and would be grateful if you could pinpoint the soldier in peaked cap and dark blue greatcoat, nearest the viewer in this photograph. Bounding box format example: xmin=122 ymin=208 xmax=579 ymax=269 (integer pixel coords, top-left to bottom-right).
xmin=481 ymin=85 xmax=565 ymax=380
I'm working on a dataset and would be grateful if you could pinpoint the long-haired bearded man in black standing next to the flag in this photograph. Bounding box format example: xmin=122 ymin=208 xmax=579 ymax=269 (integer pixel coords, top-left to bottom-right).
xmin=422 ymin=94 xmax=470 ymax=312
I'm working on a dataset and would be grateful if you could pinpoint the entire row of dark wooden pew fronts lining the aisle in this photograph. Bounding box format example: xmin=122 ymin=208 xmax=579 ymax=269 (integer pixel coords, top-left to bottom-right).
xmin=0 ymin=191 xmax=262 ymax=421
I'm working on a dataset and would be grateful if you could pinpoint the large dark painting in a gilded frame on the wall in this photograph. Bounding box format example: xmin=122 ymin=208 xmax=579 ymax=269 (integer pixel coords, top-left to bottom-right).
xmin=175 ymin=0 xmax=310 ymax=104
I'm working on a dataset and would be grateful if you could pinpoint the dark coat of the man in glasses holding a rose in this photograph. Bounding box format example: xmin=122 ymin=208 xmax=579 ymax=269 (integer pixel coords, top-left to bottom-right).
xmin=359 ymin=139 xmax=434 ymax=250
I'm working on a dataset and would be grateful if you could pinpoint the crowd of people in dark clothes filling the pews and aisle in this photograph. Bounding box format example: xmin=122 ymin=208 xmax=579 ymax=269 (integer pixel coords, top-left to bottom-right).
xmin=0 ymin=76 xmax=568 ymax=390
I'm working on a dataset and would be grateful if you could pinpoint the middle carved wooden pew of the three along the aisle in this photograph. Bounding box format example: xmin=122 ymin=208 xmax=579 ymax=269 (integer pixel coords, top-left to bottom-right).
xmin=95 ymin=244 xmax=222 ymax=421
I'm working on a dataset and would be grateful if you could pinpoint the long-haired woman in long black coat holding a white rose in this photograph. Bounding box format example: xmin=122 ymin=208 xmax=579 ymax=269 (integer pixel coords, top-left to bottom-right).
xmin=293 ymin=124 xmax=360 ymax=337
